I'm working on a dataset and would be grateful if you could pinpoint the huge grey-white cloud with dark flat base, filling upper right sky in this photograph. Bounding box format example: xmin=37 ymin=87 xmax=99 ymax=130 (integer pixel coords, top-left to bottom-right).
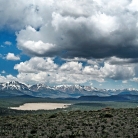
xmin=12 ymin=0 xmax=138 ymax=62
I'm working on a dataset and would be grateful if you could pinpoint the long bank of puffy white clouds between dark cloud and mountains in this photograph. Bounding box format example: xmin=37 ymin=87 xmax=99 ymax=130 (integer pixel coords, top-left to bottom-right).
xmin=14 ymin=57 xmax=135 ymax=84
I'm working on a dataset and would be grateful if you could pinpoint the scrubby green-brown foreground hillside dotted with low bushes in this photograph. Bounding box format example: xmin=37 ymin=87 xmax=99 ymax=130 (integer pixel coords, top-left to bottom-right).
xmin=0 ymin=108 xmax=138 ymax=138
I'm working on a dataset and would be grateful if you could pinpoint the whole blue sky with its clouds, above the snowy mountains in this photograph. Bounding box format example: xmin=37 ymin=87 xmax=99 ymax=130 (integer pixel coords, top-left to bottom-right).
xmin=0 ymin=0 xmax=138 ymax=89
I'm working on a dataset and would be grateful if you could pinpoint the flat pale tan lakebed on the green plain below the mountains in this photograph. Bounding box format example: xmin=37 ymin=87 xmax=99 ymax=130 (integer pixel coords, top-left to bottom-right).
xmin=10 ymin=103 xmax=71 ymax=110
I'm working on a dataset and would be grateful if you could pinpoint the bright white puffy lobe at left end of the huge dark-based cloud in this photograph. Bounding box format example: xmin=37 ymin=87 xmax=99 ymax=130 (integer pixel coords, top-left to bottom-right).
xmin=17 ymin=26 xmax=56 ymax=56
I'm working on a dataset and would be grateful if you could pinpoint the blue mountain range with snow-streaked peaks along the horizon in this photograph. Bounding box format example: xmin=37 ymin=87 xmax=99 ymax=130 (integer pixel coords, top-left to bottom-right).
xmin=0 ymin=81 xmax=138 ymax=99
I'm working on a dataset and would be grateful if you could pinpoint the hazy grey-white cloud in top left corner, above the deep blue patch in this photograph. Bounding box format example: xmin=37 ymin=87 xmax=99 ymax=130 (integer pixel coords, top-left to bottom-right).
xmin=0 ymin=0 xmax=53 ymax=30
